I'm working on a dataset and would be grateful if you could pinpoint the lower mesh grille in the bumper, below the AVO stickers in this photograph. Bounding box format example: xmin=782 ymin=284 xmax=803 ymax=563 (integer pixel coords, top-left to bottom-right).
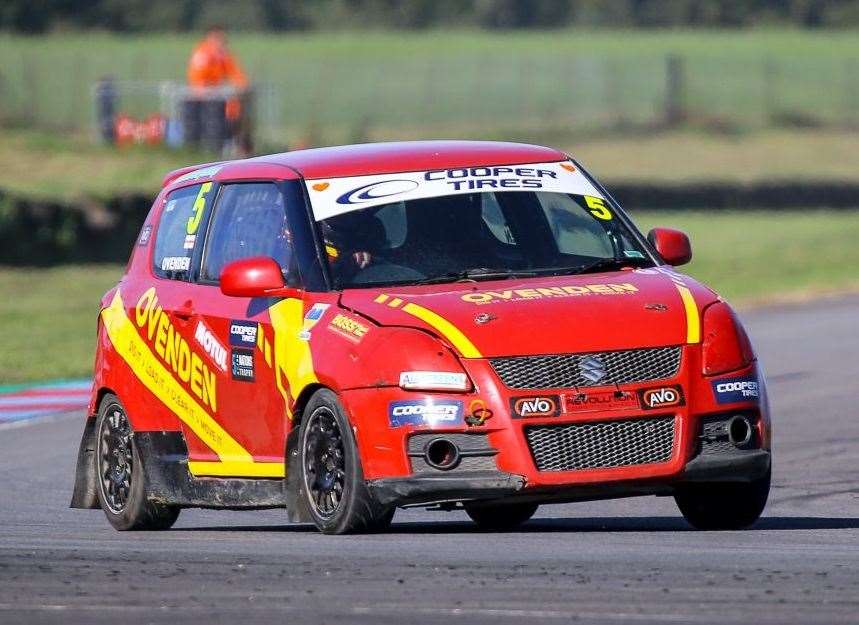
xmin=525 ymin=416 xmax=674 ymax=471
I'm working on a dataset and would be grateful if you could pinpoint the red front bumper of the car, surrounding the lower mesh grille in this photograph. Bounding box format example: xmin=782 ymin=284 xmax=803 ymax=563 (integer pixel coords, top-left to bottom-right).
xmin=344 ymin=346 xmax=770 ymax=505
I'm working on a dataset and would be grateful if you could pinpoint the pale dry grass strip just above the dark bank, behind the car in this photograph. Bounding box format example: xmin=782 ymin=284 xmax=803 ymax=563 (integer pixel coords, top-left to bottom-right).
xmin=0 ymin=129 xmax=859 ymax=201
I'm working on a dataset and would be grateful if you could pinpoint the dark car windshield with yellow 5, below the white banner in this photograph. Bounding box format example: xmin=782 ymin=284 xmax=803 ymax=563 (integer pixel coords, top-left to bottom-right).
xmin=319 ymin=191 xmax=653 ymax=289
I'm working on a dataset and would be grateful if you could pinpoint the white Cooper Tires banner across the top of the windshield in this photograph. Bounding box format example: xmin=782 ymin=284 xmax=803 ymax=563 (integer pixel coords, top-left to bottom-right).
xmin=307 ymin=161 xmax=602 ymax=221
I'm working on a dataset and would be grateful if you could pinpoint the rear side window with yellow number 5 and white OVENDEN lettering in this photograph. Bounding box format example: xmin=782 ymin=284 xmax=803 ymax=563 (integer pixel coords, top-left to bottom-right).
xmin=152 ymin=182 xmax=212 ymax=280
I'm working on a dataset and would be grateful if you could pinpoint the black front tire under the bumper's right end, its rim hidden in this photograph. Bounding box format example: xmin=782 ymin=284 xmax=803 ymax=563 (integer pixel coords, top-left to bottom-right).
xmin=674 ymin=470 xmax=772 ymax=530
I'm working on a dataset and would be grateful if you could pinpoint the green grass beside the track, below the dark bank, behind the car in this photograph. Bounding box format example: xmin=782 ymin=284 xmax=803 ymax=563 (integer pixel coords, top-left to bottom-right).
xmin=0 ymin=211 xmax=859 ymax=385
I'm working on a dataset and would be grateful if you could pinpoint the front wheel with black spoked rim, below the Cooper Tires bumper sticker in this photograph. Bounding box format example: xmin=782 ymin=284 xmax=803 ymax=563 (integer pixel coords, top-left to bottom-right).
xmin=298 ymin=389 xmax=395 ymax=534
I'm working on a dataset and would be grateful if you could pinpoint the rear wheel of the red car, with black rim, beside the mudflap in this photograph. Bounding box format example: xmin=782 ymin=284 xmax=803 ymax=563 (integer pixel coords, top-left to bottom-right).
xmin=94 ymin=394 xmax=179 ymax=531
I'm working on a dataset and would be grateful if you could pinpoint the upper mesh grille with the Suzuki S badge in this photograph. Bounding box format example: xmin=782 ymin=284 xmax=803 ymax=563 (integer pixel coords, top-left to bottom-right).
xmin=489 ymin=347 xmax=680 ymax=389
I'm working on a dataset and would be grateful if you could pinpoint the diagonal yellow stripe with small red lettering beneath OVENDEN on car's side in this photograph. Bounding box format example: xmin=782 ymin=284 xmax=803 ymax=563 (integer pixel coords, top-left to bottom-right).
xmin=101 ymin=291 xmax=282 ymax=476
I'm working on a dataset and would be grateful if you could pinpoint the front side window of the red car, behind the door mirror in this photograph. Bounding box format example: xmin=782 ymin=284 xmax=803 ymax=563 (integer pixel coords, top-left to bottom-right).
xmin=200 ymin=182 xmax=299 ymax=286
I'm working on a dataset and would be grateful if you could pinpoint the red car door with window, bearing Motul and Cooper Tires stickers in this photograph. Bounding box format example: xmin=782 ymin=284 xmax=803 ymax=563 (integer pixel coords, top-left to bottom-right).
xmin=181 ymin=182 xmax=299 ymax=477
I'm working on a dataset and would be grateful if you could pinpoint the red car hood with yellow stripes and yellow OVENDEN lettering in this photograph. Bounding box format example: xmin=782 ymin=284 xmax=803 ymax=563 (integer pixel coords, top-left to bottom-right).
xmin=341 ymin=267 xmax=717 ymax=358
